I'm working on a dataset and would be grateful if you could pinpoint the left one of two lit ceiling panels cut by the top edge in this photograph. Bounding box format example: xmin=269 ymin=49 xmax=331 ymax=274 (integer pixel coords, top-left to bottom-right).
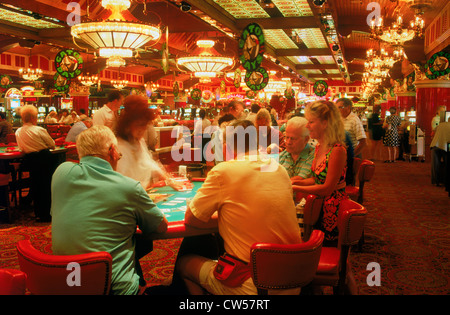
xmin=214 ymin=0 xmax=270 ymax=19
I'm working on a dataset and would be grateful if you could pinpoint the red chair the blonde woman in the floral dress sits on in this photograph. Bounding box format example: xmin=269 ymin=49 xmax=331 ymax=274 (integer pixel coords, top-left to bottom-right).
xmin=313 ymin=199 xmax=367 ymax=294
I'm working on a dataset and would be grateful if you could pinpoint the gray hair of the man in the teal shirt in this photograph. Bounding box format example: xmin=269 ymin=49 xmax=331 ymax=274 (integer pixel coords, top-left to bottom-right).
xmin=77 ymin=125 xmax=117 ymax=159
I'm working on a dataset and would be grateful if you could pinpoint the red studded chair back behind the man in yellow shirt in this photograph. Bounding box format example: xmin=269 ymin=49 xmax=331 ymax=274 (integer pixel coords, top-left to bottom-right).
xmin=250 ymin=230 xmax=324 ymax=295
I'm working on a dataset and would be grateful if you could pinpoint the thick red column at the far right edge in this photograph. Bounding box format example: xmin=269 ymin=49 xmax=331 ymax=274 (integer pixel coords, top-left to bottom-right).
xmin=415 ymin=80 xmax=450 ymax=161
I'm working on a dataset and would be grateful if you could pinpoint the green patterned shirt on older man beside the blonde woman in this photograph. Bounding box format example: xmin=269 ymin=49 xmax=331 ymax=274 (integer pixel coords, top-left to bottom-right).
xmin=279 ymin=144 xmax=314 ymax=178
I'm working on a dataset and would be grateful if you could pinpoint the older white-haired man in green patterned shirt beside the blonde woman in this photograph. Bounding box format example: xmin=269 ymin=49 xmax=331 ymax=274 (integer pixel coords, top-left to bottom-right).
xmin=279 ymin=116 xmax=314 ymax=180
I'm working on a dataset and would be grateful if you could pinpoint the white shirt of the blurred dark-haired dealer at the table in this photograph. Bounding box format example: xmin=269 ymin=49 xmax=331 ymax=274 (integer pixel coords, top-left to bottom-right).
xmin=117 ymin=137 xmax=162 ymax=189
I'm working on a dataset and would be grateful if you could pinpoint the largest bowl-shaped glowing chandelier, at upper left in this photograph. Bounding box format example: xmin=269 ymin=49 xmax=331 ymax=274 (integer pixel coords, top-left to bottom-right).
xmin=71 ymin=0 xmax=161 ymax=67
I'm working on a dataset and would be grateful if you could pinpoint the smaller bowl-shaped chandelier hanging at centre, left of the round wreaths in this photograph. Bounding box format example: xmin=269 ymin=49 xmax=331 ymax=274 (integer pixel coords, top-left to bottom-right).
xmin=177 ymin=40 xmax=234 ymax=81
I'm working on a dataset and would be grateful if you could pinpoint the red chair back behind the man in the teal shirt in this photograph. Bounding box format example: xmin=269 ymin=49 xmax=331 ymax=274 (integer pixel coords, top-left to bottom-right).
xmin=17 ymin=240 xmax=112 ymax=295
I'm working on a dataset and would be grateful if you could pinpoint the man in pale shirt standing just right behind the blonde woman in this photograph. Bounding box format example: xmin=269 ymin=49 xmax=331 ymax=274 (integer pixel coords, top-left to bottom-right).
xmin=336 ymin=98 xmax=367 ymax=158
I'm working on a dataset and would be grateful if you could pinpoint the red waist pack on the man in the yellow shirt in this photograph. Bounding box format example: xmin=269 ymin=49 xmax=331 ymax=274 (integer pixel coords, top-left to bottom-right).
xmin=213 ymin=254 xmax=251 ymax=288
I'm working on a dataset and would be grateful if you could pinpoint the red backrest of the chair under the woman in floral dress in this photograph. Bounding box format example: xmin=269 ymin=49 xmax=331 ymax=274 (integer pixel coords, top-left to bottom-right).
xmin=338 ymin=199 xmax=367 ymax=247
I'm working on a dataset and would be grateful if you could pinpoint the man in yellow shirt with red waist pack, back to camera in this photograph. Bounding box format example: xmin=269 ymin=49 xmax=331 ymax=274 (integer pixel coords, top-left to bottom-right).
xmin=175 ymin=120 xmax=301 ymax=295
